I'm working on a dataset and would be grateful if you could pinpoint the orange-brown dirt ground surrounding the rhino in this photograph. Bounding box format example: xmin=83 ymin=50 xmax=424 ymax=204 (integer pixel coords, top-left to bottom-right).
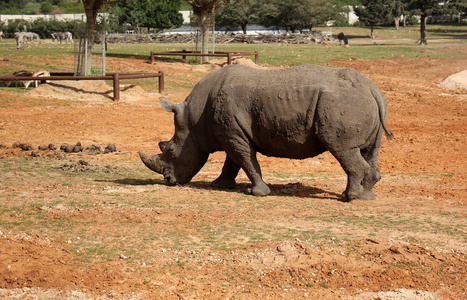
xmin=0 ymin=48 xmax=467 ymax=299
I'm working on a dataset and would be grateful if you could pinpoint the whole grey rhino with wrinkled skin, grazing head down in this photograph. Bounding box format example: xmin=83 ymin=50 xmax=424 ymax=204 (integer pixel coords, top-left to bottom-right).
xmin=140 ymin=65 xmax=392 ymax=201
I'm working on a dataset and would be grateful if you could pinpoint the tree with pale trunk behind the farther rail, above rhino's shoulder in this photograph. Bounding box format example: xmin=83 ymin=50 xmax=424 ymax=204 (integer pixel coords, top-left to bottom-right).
xmin=186 ymin=0 xmax=226 ymax=61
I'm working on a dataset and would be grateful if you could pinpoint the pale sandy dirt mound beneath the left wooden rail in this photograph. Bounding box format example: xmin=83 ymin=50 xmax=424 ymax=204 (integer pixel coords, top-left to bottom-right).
xmin=28 ymin=80 xmax=154 ymax=103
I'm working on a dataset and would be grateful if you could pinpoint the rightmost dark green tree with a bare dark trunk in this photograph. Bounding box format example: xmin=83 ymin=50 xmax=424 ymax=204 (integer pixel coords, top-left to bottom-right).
xmin=407 ymin=0 xmax=467 ymax=45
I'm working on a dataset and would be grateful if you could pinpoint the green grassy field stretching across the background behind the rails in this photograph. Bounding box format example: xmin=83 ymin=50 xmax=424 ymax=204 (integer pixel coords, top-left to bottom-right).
xmin=0 ymin=25 xmax=467 ymax=69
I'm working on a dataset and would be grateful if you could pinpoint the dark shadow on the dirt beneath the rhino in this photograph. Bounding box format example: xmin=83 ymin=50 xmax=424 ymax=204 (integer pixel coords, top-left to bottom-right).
xmin=105 ymin=178 xmax=342 ymax=201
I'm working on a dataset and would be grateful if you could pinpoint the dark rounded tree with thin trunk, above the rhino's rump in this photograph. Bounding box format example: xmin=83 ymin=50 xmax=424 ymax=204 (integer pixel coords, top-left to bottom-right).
xmin=354 ymin=0 xmax=395 ymax=39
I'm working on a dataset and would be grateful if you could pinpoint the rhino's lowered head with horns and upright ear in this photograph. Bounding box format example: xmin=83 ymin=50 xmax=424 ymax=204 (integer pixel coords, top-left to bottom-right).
xmin=139 ymin=97 xmax=209 ymax=185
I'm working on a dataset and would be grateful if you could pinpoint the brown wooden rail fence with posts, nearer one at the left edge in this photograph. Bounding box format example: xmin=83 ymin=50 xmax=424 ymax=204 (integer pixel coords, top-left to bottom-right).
xmin=0 ymin=71 xmax=165 ymax=101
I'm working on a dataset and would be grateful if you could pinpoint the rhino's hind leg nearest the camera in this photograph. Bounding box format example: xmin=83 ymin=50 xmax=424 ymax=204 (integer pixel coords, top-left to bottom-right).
xmin=332 ymin=148 xmax=370 ymax=201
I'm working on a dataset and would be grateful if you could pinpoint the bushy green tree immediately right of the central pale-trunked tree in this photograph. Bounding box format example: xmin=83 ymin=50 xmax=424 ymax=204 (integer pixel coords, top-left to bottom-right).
xmin=216 ymin=0 xmax=259 ymax=34
